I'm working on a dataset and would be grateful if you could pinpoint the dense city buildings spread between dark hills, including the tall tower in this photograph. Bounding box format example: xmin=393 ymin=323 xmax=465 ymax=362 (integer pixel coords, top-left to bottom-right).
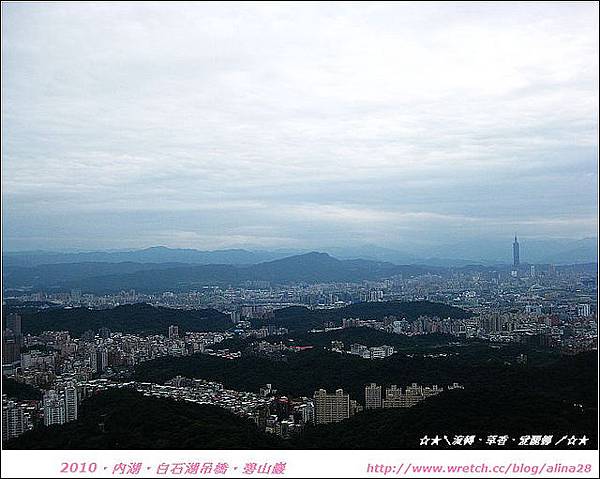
xmin=3 ymin=238 xmax=598 ymax=448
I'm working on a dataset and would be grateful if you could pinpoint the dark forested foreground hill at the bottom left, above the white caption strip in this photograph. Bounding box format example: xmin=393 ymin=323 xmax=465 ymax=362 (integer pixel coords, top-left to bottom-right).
xmin=3 ymin=390 xmax=285 ymax=450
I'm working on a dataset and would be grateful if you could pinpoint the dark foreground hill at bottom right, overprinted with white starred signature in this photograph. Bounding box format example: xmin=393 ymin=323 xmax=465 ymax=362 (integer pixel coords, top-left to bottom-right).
xmin=291 ymin=388 xmax=598 ymax=450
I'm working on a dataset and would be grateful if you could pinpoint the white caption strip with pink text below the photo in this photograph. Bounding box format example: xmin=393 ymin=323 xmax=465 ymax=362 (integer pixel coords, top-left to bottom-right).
xmin=2 ymin=450 xmax=598 ymax=479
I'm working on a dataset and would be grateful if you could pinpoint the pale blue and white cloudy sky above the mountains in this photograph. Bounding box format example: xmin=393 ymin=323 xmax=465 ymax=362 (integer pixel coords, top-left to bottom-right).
xmin=2 ymin=2 xmax=598 ymax=250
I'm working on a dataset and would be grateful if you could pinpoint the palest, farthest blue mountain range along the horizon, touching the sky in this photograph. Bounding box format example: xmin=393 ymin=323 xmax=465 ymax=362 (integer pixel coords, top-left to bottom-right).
xmin=2 ymin=238 xmax=598 ymax=267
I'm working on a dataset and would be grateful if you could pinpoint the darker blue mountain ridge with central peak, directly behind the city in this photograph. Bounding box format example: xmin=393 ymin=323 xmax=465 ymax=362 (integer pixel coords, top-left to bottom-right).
xmin=2 ymin=252 xmax=596 ymax=294
